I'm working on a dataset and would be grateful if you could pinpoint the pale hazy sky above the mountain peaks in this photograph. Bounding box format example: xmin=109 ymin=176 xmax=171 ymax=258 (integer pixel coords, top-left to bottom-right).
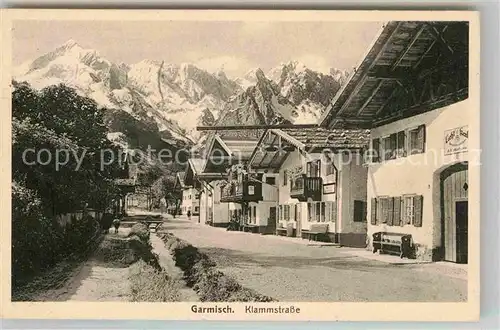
xmin=12 ymin=21 xmax=382 ymax=78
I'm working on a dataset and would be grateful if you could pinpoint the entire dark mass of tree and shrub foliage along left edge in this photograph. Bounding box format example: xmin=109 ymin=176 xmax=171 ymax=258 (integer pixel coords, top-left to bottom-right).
xmin=12 ymin=82 xmax=119 ymax=287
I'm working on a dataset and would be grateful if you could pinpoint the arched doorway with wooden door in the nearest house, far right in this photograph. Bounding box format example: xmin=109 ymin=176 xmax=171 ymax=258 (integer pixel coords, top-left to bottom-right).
xmin=440 ymin=162 xmax=469 ymax=264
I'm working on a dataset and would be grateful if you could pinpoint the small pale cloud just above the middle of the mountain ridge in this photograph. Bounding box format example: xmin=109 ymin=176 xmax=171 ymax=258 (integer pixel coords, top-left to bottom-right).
xmin=194 ymin=55 xmax=252 ymax=79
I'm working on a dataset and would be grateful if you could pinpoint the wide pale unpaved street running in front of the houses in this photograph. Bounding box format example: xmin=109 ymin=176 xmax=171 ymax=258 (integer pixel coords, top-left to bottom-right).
xmin=163 ymin=217 xmax=467 ymax=302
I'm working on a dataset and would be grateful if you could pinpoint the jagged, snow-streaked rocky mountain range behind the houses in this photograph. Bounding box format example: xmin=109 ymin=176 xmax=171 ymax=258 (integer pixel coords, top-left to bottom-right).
xmin=13 ymin=40 xmax=348 ymax=150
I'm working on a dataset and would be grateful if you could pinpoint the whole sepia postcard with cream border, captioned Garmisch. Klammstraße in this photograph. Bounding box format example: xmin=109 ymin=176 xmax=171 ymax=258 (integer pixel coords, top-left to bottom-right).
xmin=2 ymin=10 xmax=480 ymax=320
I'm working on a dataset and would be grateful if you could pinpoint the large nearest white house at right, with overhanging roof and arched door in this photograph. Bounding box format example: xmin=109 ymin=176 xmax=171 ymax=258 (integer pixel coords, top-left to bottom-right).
xmin=321 ymin=22 xmax=470 ymax=263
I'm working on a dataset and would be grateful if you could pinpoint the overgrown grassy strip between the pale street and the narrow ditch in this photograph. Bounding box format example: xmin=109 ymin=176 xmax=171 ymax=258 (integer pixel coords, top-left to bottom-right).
xmin=158 ymin=233 xmax=274 ymax=302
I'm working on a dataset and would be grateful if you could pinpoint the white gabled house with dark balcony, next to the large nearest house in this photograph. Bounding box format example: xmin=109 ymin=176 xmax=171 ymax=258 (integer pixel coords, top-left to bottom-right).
xmin=248 ymin=127 xmax=369 ymax=247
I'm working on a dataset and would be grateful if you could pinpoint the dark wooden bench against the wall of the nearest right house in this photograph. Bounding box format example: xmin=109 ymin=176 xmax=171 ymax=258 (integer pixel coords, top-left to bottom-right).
xmin=372 ymin=232 xmax=413 ymax=258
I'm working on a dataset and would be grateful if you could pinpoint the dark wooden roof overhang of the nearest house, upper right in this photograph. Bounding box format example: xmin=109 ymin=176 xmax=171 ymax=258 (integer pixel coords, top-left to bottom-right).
xmin=319 ymin=21 xmax=469 ymax=128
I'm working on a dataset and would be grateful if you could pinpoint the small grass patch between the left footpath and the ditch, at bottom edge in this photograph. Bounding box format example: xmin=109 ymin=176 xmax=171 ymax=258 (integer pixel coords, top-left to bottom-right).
xmin=129 ymin=260 xmax=180 ymax=302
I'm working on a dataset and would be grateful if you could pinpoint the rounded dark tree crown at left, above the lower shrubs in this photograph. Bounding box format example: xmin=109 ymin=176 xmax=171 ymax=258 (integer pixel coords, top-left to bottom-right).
xmin=12 ymin=83 xmax=118 ymax=215
